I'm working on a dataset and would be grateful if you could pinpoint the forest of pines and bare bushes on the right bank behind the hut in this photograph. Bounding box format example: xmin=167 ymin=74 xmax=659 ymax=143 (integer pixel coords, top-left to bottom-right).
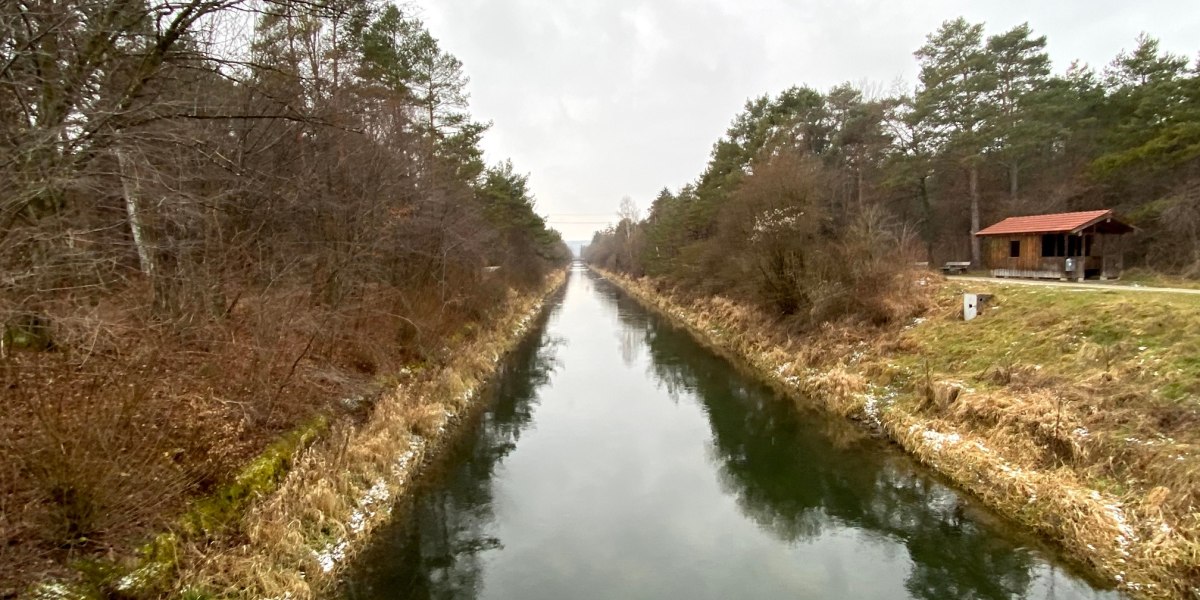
xmin=584 ymin=18 xmax=1200 ymax=322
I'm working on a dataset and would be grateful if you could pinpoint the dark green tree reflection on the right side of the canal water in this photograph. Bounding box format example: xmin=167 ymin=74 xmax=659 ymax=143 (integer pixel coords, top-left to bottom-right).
xmin=644 ymin=307 xmax=1065 ymax=599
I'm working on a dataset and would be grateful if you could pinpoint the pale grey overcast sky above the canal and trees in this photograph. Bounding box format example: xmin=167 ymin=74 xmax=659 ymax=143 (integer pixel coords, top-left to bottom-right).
xmin=416 ymin=0 xmax=1200 ymax=240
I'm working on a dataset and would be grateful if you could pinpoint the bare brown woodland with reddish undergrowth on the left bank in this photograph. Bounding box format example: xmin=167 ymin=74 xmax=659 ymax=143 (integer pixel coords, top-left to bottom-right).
xmin=0 ymin=0 xmax=570 ymax=590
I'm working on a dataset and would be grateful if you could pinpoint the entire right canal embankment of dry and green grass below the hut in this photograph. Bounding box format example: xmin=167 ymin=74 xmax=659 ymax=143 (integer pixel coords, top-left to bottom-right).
xmin=606 ymin=274 xmax=1200 ymax=598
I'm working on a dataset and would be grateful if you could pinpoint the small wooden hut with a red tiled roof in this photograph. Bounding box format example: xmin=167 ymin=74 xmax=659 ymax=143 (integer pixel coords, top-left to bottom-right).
xmin=976 ymin=210 xmax=1134 ymax=281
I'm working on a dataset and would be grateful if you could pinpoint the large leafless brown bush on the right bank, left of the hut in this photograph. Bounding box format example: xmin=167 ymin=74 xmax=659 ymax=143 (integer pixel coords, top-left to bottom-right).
xmin=672 ymin=152 xmax=929 ymax=324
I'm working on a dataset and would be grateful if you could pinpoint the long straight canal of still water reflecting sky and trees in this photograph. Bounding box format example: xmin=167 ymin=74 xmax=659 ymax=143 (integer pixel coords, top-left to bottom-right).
xmin=341 ymin=268 xmax=1118 ymax=600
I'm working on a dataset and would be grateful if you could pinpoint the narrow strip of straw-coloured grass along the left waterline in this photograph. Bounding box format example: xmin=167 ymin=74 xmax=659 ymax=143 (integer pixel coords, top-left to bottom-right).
xmin=159 ymin=271 xmax=566 ymax=600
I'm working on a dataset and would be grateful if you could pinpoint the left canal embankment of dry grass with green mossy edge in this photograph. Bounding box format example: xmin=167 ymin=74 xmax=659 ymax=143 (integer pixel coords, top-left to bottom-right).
xmin=31 ymin=271 xmax=565 ymax=600
